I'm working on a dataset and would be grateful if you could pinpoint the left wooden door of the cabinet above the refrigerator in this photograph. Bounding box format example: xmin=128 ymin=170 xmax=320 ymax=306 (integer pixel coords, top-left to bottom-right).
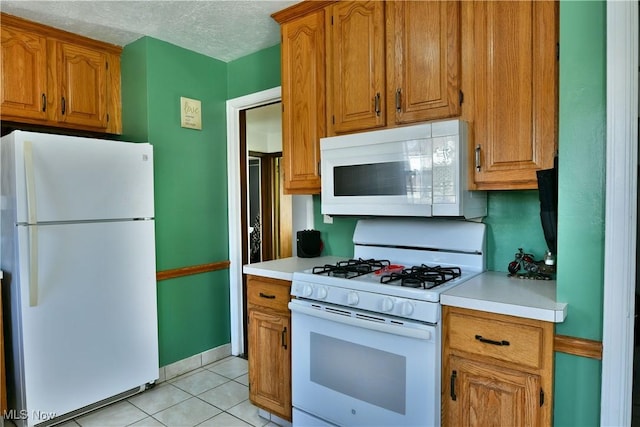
xmin=0 ymin=25 xmax=47 ymax=120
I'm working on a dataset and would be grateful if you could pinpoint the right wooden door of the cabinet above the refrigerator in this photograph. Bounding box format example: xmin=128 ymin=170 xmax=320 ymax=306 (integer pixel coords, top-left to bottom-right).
xmin=52 ymin=42 xmax=108 ymax=129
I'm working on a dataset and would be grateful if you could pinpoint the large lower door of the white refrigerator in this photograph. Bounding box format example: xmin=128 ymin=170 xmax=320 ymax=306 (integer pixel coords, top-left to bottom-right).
xmin=11 ymin=221 xmax=159 ymax=424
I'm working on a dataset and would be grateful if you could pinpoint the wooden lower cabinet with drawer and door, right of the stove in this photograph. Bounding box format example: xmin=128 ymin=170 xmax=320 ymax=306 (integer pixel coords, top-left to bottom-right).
xmin=442 ymin=306 xmax=554 ymax=427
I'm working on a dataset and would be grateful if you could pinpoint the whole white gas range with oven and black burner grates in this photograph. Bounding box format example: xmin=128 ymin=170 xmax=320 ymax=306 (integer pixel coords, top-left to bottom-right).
xmin=289 ymin=218 xmax=485 ymax=427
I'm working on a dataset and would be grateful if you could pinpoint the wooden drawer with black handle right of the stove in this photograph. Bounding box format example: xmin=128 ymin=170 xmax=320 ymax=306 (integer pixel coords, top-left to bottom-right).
xmin=448 ymin=311 xmax=544 ymax=369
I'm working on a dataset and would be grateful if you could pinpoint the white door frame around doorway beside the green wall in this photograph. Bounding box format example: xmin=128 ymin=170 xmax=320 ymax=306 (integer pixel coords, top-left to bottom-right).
xmin=227 ymin=86 xmax=282 ymax=356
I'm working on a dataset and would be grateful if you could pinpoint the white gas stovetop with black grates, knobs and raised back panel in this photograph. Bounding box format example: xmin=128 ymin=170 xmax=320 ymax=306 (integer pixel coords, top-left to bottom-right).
xmin=291 ymin=218 xmax=485 ymax=323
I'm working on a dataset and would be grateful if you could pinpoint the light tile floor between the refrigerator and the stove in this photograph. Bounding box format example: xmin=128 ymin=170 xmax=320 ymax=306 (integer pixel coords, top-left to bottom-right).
xmin=8 ymin=357 xmax=277 ymax=427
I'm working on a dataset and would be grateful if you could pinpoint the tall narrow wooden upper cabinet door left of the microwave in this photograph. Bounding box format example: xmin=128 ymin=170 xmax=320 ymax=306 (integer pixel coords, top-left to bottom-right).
xmin=281 ymin=10 xmax=326 ymax=194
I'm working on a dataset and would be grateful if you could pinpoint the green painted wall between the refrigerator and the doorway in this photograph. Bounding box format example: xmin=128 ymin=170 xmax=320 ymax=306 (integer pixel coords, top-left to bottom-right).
xmin=122 ymin=38 xmax=230 ymax=366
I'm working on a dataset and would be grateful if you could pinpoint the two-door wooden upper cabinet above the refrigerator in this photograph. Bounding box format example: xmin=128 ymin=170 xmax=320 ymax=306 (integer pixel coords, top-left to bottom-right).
xmin=0 ymin=14 xmax=122 ymax=133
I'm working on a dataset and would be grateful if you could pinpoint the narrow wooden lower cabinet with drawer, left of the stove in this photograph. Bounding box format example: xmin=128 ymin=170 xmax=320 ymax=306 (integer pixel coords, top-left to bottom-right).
xmin=247 ymin=276 xmax=291 ymax=421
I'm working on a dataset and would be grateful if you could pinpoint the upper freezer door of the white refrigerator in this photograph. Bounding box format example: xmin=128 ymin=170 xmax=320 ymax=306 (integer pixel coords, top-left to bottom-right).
xmin=9 ymin=132 xmax=154 ymax=224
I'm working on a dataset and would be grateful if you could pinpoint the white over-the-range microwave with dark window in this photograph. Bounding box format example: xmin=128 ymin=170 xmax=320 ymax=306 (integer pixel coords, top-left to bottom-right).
xmin=320 ymin=120 xmax=487 ymax=219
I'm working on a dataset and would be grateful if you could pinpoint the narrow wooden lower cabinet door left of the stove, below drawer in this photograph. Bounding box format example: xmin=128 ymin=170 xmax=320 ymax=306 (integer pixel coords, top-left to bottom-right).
xmin=249 ymin=307 xmax=291 ymax=421
